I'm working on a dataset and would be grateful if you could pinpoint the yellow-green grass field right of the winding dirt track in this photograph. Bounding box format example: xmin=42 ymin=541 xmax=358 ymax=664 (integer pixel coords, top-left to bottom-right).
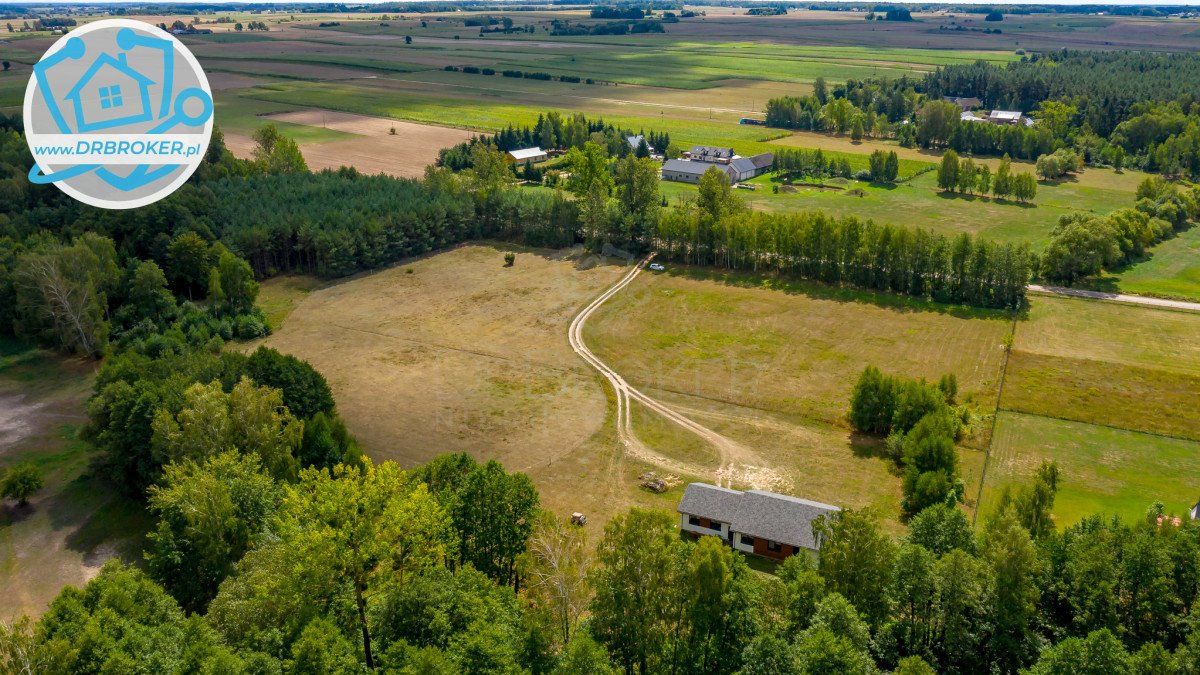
xmin=584 ymin=263 xmax=1009 ymax=526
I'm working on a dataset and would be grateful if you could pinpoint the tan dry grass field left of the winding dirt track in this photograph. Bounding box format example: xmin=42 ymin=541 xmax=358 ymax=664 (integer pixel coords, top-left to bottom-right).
xmin=266 ymin=245 xmax=622 ymax=471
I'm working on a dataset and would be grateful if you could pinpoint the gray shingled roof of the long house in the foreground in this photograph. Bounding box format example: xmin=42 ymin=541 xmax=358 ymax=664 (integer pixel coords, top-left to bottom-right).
xmin=678 ymin=483 xmax=841 ymax=549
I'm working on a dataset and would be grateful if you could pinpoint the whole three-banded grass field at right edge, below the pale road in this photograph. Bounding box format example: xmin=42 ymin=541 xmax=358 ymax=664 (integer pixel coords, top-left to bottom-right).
xmin=982 ymin=295 xmax=1200 ymax=524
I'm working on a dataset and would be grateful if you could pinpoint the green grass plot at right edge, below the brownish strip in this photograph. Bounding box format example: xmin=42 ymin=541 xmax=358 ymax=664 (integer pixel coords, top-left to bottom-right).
xmin=980 ymin=412 xmax=1200 ymax=527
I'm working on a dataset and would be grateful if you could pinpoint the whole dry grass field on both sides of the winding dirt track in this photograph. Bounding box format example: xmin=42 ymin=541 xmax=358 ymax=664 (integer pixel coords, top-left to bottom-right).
xmin=262 ymin=245 xmax=1009 ymax=530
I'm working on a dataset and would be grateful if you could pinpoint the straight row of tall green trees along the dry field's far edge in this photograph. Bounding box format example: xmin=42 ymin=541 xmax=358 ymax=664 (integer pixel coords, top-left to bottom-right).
xmin=654 ymin=169 xmax=1034 ymax=307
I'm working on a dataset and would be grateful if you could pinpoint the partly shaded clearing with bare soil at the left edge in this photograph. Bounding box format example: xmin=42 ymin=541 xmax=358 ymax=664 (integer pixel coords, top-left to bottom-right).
xmin=0 ymin=339 xmax=149 ymax=621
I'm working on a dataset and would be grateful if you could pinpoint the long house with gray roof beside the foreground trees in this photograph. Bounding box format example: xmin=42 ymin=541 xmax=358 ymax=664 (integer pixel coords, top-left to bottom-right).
xmin=677 ymin=483 xmax=841 ymax=560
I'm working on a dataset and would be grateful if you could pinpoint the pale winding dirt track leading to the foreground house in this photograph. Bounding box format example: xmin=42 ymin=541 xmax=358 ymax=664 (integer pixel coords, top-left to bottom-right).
xmin=568 ymin=253 xmax=781 ymax=488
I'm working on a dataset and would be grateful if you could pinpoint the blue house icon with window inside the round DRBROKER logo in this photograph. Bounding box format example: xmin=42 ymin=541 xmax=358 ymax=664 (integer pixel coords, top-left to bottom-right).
xmin=64 ymin=53 xmax=154 ymax=133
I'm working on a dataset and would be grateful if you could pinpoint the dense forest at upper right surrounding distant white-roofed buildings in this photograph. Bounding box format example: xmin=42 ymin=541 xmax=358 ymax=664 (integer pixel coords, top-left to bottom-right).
xmin=767 ymin=49 xmax=1200 ymax=179
